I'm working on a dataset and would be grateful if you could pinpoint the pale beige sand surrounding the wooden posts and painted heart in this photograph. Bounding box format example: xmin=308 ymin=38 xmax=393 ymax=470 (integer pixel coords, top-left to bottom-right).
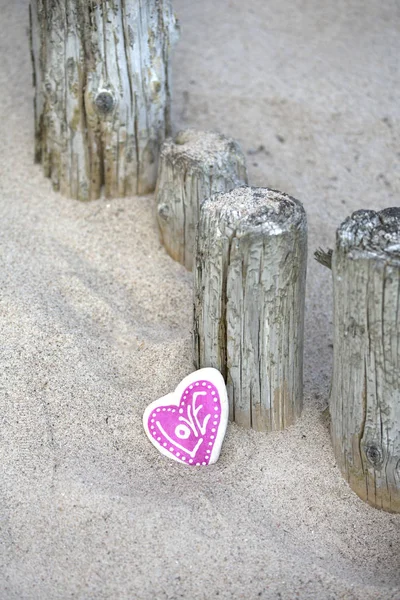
xmin=0 ymin=0 xmax=400 ymax=600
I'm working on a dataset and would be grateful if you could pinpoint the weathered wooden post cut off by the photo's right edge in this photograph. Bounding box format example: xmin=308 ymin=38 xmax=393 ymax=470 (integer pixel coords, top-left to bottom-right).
xmin=330 ymin=208 xmax=400 ymax=512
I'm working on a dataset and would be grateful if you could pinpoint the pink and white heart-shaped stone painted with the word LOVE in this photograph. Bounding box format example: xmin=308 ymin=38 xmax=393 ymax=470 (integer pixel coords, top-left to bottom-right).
xmin=143 ymin=368 xmax=229 ymax=466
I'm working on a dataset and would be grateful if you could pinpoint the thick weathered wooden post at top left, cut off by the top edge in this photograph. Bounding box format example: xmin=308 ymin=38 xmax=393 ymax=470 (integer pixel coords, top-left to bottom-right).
xmin=30 ymin=0 xmax=177 ymax=200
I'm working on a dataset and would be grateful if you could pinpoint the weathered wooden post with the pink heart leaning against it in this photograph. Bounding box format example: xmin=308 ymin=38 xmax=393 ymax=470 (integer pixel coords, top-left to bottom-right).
xmin=194 ymin=187 xmax=307 ymax=431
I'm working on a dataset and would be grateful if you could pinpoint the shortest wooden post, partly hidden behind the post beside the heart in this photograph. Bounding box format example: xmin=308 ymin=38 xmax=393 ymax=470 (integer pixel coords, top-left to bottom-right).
xmin=156 ymin=130 xmax=247 ymax=271
